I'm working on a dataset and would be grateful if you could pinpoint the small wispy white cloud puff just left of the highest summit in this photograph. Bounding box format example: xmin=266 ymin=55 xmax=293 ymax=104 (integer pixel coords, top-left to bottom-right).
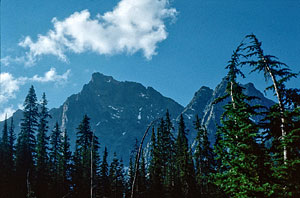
xmin=30 ymin=67 xmax=71 ymax=84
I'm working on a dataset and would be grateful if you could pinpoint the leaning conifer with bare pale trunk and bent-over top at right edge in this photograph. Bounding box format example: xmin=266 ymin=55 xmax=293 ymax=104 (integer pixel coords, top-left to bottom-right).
xmin=243 ymin=34 xmax=300 ymax=197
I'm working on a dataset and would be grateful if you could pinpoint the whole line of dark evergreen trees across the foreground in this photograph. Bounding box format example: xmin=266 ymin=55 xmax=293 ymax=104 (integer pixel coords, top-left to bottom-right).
xmin=0 ymin=34 xmax=300 ymax=198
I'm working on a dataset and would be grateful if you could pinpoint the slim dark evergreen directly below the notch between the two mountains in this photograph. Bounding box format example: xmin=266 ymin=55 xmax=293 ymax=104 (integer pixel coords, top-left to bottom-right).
xmin=176 ymin=115 xmax=197 ymax=197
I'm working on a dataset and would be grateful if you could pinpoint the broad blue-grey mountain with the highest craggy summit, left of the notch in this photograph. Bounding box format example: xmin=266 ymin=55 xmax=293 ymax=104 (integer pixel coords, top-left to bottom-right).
xmin=0 ymin=73 xmax=184 ymax=162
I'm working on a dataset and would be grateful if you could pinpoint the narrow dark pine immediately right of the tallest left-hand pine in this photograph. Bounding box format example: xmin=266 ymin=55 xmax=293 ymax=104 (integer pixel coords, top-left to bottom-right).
xmin=35 ymin=93 xmax=50 ymax=197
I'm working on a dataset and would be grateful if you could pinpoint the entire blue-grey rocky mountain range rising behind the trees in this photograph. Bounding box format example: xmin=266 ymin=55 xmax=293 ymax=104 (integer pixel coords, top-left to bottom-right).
xmin=0 ymin=73 xmax=274 ymax=163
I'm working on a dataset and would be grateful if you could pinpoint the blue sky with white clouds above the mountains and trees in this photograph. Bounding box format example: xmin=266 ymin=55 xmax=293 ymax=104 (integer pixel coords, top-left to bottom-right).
xmin=0 ymin=0 xmax=300 ymax=120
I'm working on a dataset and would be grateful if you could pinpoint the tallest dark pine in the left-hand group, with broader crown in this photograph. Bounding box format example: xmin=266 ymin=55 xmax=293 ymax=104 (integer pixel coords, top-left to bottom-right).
xmin=16 ymin=86 xmax=38 ymax=197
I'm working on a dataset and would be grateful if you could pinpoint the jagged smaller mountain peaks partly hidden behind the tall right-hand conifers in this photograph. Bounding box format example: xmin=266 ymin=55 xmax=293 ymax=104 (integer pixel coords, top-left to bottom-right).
xmin=176 ymin=78 xmax=274 ymax=144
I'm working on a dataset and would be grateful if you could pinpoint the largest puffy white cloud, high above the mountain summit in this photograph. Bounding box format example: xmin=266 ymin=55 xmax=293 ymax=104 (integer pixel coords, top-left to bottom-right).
xmin=19 ymin=0 xmax=177 ymax=63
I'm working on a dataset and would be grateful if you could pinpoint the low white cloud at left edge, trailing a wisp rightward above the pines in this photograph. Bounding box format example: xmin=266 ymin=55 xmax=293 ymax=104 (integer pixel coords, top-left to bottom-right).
xmin=0 ymin=68 xmax=71 ymax=105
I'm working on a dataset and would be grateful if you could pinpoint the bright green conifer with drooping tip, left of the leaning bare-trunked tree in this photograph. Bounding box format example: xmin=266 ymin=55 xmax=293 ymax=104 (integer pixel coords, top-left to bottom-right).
xmin=216 ymin=45 xmax=271 ymax=197
